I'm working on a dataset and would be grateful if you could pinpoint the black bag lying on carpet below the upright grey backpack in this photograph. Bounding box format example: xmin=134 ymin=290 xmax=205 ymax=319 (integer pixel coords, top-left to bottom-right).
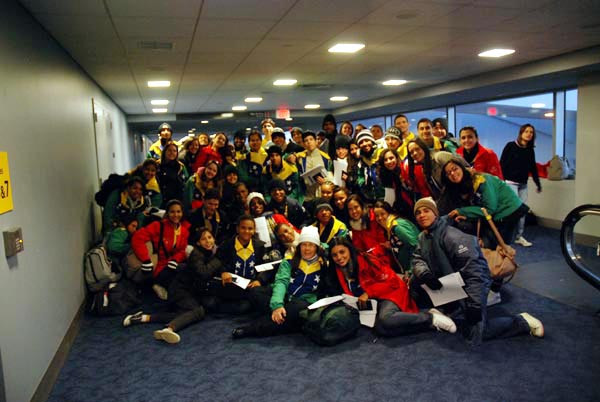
xmin=86 ymin=280 xmax=142 ymax=316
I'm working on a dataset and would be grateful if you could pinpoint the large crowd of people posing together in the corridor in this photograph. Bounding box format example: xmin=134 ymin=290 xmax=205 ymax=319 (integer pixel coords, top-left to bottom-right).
xmin=98 ymin=114 xmax=544 ymax=345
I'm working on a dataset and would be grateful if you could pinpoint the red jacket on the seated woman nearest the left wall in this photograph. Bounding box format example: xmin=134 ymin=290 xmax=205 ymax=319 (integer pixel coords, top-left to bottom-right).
xmin=131 ymin=219 xmax=189 ymax=277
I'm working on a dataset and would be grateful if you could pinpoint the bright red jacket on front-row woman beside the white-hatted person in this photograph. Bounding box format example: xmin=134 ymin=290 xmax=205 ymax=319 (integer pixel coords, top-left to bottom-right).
xmin=336 ymin=254 xmax=419 ymax=313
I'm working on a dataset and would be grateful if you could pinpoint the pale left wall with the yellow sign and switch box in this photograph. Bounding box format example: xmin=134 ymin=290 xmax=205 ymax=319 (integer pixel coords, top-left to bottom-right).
xmin=0 ymin=0 xmax=132 ymax=401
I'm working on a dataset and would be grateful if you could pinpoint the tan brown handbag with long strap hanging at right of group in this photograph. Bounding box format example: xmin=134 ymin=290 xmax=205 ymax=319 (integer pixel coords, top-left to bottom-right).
xmin=477 ymin=208 xmax=519 ymax=282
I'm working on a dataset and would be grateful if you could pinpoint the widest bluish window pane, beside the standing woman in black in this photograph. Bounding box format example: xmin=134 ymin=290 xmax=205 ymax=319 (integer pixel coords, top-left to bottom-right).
xmin=456 ymin=93 xmax=554 ymax=163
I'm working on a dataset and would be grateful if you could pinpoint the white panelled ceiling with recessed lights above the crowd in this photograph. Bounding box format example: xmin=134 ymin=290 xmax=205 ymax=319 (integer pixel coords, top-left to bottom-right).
xmin=21 ymin=0 xmax=600 ymax=119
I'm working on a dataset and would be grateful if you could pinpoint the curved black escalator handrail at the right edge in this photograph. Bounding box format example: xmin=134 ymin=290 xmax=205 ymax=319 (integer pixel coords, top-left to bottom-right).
xmin=560 ymin=204 xmax=600 ymax=290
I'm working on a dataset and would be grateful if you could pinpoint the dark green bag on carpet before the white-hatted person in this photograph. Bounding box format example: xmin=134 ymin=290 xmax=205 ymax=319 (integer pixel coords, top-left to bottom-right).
xmin=300 ymin=301 xmax=360 ymax=346
